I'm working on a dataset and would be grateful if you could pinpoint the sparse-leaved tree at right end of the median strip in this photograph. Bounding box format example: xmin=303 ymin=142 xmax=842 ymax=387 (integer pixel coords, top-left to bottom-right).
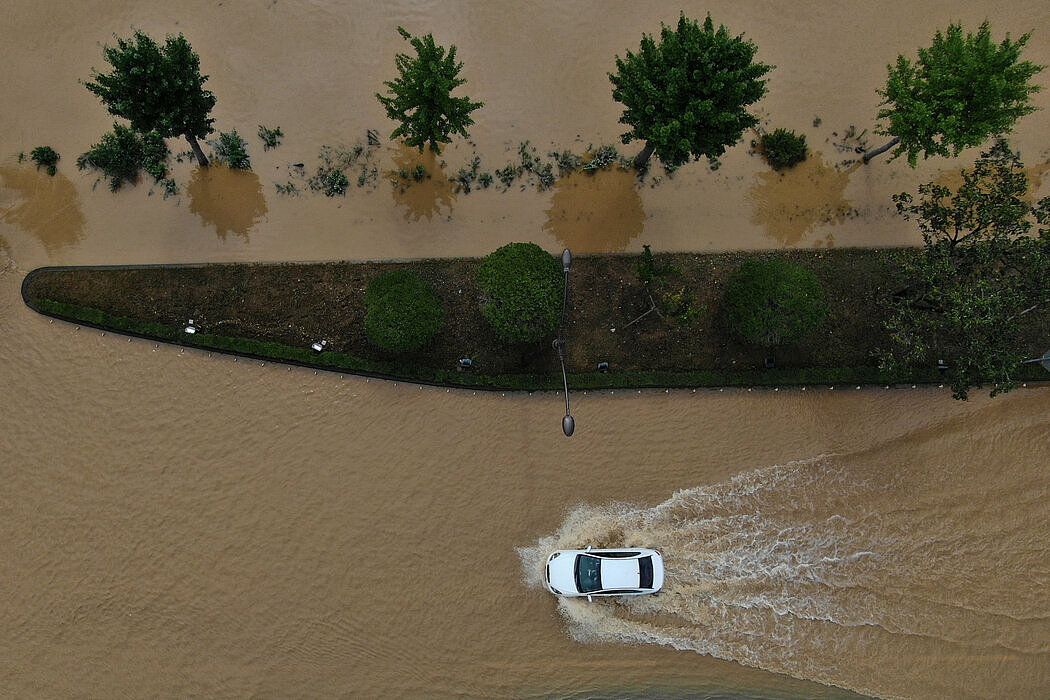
xmin=882 ymin=142 xmax=1050 ymax=399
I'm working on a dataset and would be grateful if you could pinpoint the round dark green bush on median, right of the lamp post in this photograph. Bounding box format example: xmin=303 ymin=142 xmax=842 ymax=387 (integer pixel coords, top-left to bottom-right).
xmin=726 ymin=257 xmax=827 ymax=346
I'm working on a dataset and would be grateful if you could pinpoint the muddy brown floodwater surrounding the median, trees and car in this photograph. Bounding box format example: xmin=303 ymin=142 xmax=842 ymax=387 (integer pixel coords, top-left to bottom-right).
xmin=0 ymin=0 xmax=1050 ymax=698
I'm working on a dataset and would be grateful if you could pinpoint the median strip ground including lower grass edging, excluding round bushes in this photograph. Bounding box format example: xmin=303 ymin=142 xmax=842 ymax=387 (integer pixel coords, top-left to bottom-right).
xmin=23 ymin=249 xmax=1040 ymax=390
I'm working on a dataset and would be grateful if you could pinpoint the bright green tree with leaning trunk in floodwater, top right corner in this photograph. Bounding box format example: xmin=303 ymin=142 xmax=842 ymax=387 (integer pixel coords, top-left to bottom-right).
xmin=864 ymin=22 xmax=1044 ymax=167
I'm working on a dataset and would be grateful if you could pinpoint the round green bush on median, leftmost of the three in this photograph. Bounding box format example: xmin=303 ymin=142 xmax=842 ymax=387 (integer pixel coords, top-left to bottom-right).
xmin=364 ymin=270 xmax=444 ymax=353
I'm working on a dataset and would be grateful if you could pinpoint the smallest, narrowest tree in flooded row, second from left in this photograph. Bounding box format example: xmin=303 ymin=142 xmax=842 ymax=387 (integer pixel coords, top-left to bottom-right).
xmin=376 ymin=26 xmax=484 ymax=152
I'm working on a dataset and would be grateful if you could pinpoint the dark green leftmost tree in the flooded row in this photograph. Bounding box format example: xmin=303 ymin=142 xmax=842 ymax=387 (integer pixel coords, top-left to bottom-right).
xmin=84 ymin=31 xmax=215 ymax=166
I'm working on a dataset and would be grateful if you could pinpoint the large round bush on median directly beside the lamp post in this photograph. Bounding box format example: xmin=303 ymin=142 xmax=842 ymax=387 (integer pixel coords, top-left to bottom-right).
xmin=478 ymin=243 xmax=562 ymax=343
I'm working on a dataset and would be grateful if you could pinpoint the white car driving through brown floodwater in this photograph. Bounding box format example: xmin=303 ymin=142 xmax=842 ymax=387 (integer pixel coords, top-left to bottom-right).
xmin=545 ymin=547 xmax=664 ymax=600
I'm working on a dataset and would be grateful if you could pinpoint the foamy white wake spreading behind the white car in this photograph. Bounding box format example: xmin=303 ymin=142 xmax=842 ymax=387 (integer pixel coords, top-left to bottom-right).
xmin=518 ymin=455 xmax=1050 ymax=693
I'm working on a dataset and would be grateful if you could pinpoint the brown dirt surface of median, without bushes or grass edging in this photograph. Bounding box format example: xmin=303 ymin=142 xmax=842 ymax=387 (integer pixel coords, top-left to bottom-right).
xmin=26 ymin=249 xmax=919 ymax=374
